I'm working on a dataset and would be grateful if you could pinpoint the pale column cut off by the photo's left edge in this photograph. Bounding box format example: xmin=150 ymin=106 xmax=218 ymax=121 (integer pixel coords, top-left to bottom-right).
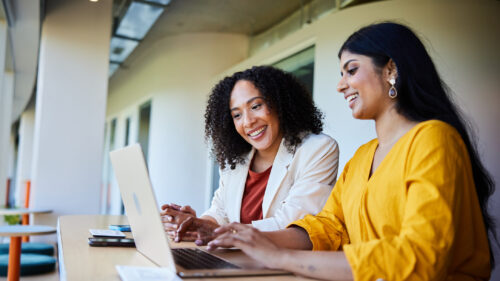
xmin=0 ymin=20 xmax=8 ymax=205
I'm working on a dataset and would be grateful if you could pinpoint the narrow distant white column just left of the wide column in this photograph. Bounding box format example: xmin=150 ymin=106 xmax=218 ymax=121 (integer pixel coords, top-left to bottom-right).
xmin=16 ymin=106 xmax=35 ymax=206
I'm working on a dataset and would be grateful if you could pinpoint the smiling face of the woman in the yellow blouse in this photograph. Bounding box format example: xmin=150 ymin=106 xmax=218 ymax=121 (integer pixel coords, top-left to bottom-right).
xmin=337 ymin=51 xmax=395 ymax=120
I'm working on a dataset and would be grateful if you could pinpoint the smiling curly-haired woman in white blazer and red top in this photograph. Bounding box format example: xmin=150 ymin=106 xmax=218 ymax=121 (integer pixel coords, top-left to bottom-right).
xmin=162 ymin=66 xmax=338 ymax=244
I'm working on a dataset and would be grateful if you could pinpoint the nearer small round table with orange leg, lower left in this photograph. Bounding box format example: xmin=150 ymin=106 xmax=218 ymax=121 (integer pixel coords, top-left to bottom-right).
xmin=0 ymin=225 xmax=56 ymax=281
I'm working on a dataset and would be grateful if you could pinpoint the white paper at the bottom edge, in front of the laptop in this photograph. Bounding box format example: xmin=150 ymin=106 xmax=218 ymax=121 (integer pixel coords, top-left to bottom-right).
xmin=116 ymin=265 xmax=182 ymax=281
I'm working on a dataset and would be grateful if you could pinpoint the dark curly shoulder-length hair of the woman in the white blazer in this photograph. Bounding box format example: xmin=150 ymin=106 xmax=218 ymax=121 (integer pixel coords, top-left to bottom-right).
xmin=205 ymin=66 xmax=323 ymax=169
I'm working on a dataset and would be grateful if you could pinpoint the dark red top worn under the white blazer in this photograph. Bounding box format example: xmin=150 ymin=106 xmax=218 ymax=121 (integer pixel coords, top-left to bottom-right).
xmin=240 ymin=166 xmax=273 ymax=224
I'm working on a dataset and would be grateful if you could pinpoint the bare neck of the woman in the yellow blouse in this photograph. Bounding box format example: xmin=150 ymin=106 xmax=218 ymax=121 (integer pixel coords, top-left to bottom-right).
xmin=375 ymin=104 xmax=417 ymax=146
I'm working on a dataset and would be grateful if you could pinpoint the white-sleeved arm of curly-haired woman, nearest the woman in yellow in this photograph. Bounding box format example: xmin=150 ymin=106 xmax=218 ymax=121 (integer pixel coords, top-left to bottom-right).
xmin=252 ymin=135 xmax=339 ymax=231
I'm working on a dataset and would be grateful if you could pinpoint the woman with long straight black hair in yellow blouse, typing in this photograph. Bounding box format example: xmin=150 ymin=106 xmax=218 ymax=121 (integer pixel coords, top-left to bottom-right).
xmin=209 ymin=23 xmax=493 ymax=280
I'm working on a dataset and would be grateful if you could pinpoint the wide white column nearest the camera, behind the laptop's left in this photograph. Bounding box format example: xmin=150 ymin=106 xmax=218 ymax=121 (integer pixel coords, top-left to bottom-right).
xmin=30 ymin=0 xmax=113 ymax=225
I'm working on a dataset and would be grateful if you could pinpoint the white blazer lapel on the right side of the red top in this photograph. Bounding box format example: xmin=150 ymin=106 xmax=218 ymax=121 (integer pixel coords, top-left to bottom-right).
xmin=262 ymin=139 xmax=293 ymax=218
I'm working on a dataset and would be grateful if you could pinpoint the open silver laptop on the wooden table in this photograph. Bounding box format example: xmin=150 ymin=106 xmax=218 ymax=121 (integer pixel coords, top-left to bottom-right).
xmin=110 ymin=144 xmax=290 ymax=277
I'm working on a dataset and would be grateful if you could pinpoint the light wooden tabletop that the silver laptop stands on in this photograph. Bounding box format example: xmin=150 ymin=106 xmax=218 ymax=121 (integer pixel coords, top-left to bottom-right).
xmin=57 ymin=215 xmax=307 ymax=281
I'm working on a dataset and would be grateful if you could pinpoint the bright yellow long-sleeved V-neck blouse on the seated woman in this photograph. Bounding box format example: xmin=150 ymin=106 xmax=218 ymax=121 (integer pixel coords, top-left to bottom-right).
xmin=292 ymin=120 xmax=490 ymax=280
